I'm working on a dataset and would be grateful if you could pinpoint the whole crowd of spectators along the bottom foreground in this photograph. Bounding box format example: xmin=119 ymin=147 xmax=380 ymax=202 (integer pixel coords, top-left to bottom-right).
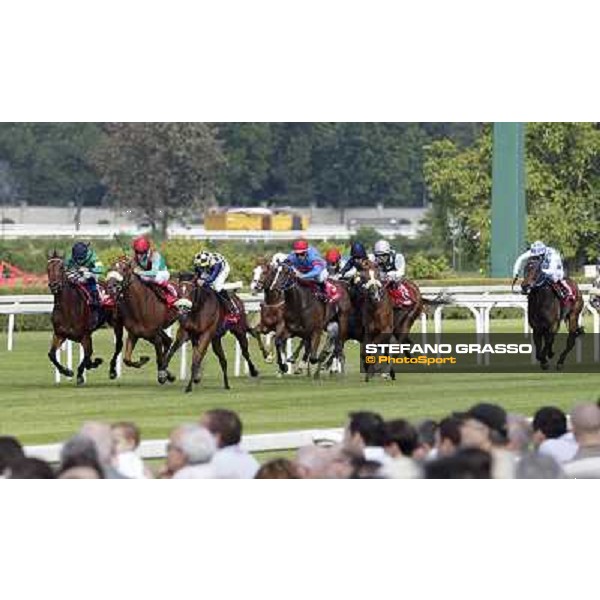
xmin=0 ymin=401 xmax=600 ymax=479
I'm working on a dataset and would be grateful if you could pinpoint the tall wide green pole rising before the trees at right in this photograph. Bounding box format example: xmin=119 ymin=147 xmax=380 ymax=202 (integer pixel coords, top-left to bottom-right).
xmin=491 ymin=123 xmax=527 ymax=277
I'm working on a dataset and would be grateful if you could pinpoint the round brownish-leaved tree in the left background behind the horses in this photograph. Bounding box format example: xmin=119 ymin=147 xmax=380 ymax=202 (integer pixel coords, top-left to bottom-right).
xmin=94 ymin=123 xmax=224 ymax=236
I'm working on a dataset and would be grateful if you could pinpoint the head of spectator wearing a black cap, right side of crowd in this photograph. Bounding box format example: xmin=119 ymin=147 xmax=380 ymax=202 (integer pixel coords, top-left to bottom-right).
xmin=460 ymin=403 xmax=508 ymax=451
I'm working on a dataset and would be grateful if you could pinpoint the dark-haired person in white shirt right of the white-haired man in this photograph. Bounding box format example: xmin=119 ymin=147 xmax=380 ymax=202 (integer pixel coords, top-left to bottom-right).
xmin=201 ymin=408 xmax=260 ymax=479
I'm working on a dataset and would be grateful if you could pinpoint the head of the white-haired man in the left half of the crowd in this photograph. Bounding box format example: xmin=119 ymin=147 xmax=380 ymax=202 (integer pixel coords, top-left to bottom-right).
xmin=167 ymin=423 xmax=217 ymax=473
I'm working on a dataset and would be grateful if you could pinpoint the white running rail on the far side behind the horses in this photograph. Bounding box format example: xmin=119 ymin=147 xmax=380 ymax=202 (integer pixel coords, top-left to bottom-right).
xmin=0 ymin=284 xmax=600 ymax=382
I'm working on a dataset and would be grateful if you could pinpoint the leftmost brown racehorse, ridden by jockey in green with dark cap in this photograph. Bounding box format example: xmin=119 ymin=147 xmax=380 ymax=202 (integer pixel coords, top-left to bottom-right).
xmin=46 ymin=250 xmax=123 ymax=385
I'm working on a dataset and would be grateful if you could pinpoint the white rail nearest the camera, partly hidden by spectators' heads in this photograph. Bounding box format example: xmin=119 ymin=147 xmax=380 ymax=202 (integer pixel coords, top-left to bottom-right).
xmin=25 ymin=429 xmax=344 ymax=463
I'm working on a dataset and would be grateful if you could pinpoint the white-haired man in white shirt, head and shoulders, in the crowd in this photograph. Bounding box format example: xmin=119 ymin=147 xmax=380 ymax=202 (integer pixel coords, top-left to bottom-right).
xmin=163 ymin=423 xmax=217 ymax=479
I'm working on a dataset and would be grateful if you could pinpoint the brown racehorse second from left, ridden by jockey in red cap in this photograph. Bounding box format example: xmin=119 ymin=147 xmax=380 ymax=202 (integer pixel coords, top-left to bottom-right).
xmin=106 ymin=257 xmax=179 ymax=384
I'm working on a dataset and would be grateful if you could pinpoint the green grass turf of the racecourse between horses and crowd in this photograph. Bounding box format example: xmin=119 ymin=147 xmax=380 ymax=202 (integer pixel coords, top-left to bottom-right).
xmin=0 ymin=320 xmax=600 ymax=444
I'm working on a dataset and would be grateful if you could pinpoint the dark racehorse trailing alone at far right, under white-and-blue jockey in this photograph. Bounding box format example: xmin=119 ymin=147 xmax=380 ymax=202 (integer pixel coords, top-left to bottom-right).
xmin=521 ymin=257 xmax=584 ymax=371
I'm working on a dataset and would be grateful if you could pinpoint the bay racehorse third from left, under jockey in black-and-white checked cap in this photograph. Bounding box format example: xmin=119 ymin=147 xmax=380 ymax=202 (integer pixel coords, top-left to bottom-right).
xmin=166 ymin=273 xmax=266 ymax=392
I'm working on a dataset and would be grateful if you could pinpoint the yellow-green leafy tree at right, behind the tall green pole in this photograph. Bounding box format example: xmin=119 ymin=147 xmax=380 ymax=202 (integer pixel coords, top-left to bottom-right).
xmin=425 ymin=123 xmax=600 ymax=267
